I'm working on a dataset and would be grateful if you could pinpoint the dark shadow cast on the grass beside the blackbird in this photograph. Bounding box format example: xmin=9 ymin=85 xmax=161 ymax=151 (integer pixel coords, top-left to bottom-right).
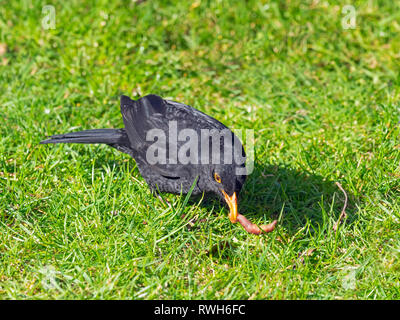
xmin=233 ymin=165 xmax=358 ymax=233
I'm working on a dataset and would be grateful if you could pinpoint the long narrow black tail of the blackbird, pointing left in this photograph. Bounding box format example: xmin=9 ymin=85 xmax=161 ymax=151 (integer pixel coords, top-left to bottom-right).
xmin=40 ymin=129 xmax=128 ymax=145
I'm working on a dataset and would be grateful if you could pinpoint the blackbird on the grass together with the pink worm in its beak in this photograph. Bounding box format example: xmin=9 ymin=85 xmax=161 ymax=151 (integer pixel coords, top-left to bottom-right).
xmin=40 ymin=94 xmax=275 ymax=234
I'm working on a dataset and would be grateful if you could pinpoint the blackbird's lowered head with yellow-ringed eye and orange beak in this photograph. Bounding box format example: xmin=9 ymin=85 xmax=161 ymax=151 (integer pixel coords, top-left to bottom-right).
xmin=208 ymin=165 xmax=246 ymax=223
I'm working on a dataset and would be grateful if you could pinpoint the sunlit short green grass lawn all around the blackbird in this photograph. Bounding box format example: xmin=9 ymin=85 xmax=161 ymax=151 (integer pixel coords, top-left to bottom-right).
xmin=0 ymin=0 xmax=400 ymax=299
